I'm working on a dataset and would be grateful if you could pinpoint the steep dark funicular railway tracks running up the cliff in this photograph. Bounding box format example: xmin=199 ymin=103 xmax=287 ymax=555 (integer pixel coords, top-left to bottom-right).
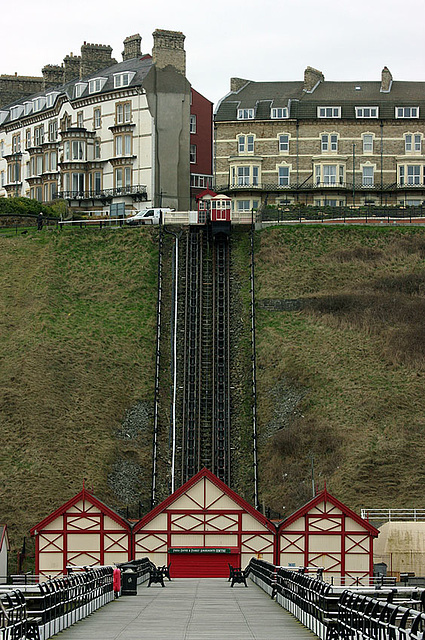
xmin=181 ymin=229 xmax=230 ymax=483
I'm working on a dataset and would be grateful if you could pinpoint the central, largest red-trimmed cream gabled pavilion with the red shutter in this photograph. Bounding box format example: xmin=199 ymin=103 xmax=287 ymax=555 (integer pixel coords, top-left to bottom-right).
xmin=133 ymin=469 xmax=276 ymax=578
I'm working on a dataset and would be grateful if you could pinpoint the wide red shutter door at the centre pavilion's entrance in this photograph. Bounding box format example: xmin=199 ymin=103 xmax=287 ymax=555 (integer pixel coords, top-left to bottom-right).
xmin=168 ymin=553 xmax=240 ymax=578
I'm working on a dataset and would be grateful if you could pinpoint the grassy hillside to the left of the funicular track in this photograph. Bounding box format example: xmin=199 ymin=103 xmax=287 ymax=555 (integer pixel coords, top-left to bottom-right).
xmin=0 ymin=230 xmax=157 ymax=544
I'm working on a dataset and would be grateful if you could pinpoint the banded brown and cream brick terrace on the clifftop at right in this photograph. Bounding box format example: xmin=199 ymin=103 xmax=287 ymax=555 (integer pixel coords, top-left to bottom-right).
xmin=215 ymin=67 xmax=425 ymax=211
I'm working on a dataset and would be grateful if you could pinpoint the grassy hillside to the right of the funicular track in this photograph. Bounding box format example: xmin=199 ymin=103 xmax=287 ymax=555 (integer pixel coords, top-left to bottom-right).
xmin=248 ymin=226 xmax=425 ymax=514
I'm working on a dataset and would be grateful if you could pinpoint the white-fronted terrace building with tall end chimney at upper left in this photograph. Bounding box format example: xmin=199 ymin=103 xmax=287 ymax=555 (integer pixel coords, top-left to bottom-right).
xmin=0 ymin=30 xmax=212 ymax=213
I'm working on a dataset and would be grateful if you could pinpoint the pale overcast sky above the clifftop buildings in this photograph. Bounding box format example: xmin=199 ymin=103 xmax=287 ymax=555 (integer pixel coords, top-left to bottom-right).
xmin=0 ymin=0 xmax=425 ymax=103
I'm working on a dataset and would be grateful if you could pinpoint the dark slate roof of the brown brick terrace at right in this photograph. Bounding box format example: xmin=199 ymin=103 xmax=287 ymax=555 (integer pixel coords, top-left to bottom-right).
xmin=215 ymin=80 xmax=425 ymax=122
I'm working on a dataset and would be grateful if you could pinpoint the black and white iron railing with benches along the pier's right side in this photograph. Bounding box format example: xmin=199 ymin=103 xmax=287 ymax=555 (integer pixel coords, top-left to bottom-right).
xmin=248 ymin=559 xmax=425 ymax=640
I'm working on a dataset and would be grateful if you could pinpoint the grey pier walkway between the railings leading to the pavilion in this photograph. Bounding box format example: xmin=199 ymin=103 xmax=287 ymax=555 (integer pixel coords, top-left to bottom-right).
xmin=59 ymin=578 xmax=316 ymax=640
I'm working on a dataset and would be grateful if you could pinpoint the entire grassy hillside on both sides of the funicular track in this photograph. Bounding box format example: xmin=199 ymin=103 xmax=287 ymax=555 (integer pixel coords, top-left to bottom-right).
xmin=0 ymin=226 xmax=425 ymax=564
